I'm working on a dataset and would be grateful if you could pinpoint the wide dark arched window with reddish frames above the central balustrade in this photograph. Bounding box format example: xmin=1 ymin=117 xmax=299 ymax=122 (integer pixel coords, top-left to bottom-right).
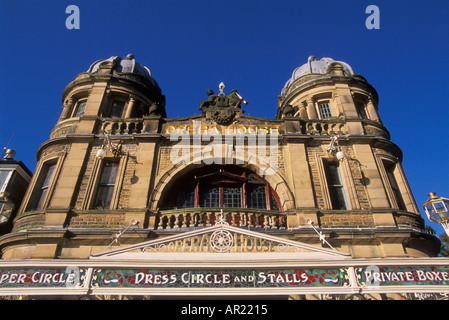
xmin=161 ymin=167 xmax=281 ymax=210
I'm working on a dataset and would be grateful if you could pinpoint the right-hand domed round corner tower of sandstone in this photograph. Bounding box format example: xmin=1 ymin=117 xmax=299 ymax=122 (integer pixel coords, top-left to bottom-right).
xmin=276 ymin=56 xmax=438 ymax=257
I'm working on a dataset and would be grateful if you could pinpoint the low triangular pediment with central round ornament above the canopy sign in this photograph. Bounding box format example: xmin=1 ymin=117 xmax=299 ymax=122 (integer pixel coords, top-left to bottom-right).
xmin=91 ymin=221 xmax=350 ymax=260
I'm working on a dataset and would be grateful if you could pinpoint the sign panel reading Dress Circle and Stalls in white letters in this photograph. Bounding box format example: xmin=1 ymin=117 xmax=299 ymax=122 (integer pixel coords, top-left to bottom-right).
xmin=93 ymin=269 xmax=349 ymax=288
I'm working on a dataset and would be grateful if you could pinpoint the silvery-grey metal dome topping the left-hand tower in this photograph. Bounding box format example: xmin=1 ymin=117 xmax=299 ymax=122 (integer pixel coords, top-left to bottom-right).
xmin=87 ymin=54 xmax=159 ymax=87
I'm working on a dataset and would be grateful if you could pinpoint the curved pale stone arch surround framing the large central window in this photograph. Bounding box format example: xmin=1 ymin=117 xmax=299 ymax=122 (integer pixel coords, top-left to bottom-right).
xmin=148 ymin=158 xmax=295 ymax=211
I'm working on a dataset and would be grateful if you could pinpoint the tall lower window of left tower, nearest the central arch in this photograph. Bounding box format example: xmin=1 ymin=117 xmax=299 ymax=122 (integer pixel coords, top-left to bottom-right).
xmin=91 ymin=162 xmax=118 ymax=209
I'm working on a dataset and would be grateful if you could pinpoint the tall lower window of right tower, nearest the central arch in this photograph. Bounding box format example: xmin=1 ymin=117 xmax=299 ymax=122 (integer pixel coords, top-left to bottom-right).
xmin=325 ymin=162 xmax=348 ymax=210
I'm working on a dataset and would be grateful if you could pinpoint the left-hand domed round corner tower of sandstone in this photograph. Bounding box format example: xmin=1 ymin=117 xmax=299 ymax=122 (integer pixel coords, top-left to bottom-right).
xmin=2 ymin=54 xmax=166 ymax=258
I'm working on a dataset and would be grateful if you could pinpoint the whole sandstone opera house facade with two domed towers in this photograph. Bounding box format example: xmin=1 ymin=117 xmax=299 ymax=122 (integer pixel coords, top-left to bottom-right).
xmin=0 ymin=55 xmax=439 ymax=259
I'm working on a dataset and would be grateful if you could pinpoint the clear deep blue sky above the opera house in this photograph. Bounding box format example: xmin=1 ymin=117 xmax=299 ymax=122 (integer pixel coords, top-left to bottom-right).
xmin=0 ymin=0 xmax=449 ymax=233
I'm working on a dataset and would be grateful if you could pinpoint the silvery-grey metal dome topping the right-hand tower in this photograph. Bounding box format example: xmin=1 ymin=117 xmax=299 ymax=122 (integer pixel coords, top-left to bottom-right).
xmin=282 ymin=56 xmax=354 ymax=94
